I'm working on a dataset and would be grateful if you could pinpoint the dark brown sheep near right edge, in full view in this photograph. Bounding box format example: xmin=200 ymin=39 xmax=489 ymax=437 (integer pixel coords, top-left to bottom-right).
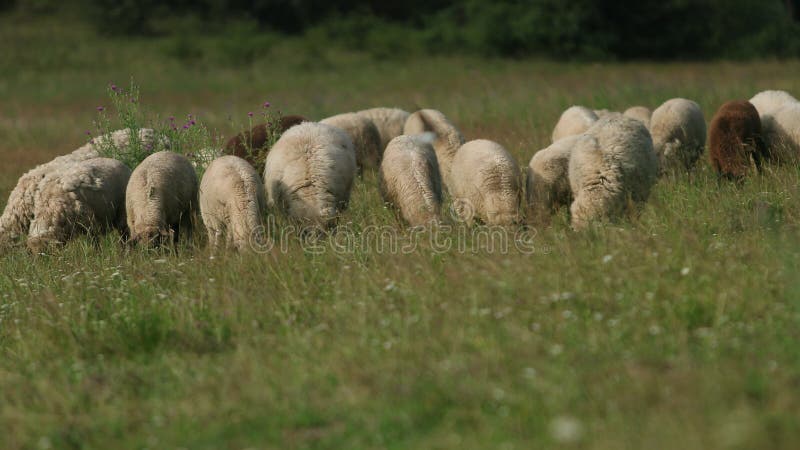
xmin=708 ymin=100 xmax=767 ymax=179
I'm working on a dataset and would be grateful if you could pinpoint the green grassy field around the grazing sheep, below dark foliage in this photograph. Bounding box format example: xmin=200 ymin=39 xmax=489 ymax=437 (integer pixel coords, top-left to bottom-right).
xmin=0 ymin=15 xmax=800 ymax=450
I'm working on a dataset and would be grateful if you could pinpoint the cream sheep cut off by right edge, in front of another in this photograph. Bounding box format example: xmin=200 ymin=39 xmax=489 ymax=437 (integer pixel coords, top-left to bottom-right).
xmin=761 ymin=102 xmax=800 ymax=164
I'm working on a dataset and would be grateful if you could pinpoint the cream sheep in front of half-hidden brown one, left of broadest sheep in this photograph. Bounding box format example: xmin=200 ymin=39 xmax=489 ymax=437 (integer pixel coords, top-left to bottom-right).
xmin=200 ymin=155 xmax=267 ymax=251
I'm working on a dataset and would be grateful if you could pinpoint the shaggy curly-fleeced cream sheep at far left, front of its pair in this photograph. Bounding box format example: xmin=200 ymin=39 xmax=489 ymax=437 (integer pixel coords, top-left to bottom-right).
xmin=28 ymin=158 xmax=131 ymax=252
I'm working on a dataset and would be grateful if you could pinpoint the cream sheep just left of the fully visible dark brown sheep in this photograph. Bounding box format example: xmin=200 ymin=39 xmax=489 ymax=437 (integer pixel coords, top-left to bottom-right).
xmin=650 ymin=98 xmax=706 ymax=173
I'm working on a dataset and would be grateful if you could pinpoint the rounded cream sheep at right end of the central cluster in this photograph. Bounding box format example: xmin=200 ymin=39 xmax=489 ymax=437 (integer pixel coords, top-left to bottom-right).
xmin=450 ymin=139 xmax=522 ymax=225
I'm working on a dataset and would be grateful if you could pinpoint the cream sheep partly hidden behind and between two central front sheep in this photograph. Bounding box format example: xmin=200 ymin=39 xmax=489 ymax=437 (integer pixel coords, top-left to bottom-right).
xmin=403 ymin=109 xmax=464 ymax=192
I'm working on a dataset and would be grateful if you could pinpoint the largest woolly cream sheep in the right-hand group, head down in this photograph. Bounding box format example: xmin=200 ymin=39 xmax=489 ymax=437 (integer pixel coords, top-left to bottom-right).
xmin=568 ymin=115 xmax=658 ymax=230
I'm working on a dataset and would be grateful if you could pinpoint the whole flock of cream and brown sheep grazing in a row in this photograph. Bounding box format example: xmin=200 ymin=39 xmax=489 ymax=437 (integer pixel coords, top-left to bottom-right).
xmin=0 ymin=91 xmax=800 ymax=252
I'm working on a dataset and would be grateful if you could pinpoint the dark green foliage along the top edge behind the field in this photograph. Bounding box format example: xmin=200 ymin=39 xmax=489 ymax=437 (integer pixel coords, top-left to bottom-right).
xmin=0 ymin=0 xmax=800 ymax=62
